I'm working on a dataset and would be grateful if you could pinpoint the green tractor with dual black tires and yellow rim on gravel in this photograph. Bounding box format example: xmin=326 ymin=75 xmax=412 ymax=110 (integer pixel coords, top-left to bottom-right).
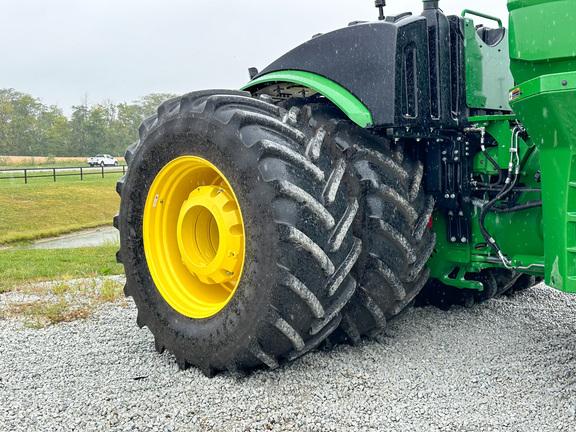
xmin=114 ymin=0 xmax=576 ymax=376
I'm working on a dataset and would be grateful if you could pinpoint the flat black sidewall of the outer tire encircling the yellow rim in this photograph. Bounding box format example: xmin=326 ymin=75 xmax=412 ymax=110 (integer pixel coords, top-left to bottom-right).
xmin=120 ymin=112 xmax=279 ymax=365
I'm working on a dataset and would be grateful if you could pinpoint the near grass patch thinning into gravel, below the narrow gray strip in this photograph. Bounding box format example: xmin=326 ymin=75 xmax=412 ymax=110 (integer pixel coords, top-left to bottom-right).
xmin=0 ymin=245 xmax=124 ymax=328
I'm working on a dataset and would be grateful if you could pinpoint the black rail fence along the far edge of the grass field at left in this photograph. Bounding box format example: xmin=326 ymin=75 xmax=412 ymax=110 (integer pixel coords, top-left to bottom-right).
xmin=0 ymin=165 xmax=127 ymax=184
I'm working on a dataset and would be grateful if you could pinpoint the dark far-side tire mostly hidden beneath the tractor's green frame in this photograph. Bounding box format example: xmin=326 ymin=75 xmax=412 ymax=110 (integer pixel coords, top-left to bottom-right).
xmin=416 ymin=268 xmax=543 ymax=310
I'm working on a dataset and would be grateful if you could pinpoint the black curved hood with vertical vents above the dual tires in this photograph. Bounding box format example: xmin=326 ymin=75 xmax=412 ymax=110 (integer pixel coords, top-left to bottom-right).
xmin=244 ymin=11 xmax=465 ymax=127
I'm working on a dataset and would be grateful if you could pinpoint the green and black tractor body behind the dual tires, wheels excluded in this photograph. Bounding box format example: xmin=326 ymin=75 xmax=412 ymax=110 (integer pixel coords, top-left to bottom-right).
xmin=245 ymin=1 xmax=576 ymax=292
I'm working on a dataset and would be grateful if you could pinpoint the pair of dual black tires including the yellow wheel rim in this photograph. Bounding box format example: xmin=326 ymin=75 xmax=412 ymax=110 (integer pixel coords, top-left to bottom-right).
xmin=114 ymin=91 xmax=434 ymax=376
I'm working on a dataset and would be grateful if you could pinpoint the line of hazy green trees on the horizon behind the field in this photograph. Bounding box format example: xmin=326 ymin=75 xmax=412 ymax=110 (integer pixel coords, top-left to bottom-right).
xmin=0 ymin=89 xmax=175 ymax=157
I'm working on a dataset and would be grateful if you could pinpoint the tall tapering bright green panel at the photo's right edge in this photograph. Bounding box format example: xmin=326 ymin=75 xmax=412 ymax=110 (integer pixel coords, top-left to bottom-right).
xmin=508 ymin=1 xmax=576 ymax=292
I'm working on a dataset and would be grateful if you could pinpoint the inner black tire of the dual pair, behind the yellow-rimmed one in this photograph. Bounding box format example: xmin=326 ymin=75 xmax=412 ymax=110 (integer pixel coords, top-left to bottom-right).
xmin=276 ymin=99 xmax=435 ymax=344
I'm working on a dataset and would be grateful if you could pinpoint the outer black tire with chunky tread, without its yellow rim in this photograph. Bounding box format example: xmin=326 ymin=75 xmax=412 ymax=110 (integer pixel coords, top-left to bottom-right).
xmin=115 ymin=91 xmax=361 ymax=375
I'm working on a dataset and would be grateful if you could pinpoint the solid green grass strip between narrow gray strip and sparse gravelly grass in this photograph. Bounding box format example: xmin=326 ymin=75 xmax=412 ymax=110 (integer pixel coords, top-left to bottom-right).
xmin=0 ymin=245 xmax=124 ymax=293
